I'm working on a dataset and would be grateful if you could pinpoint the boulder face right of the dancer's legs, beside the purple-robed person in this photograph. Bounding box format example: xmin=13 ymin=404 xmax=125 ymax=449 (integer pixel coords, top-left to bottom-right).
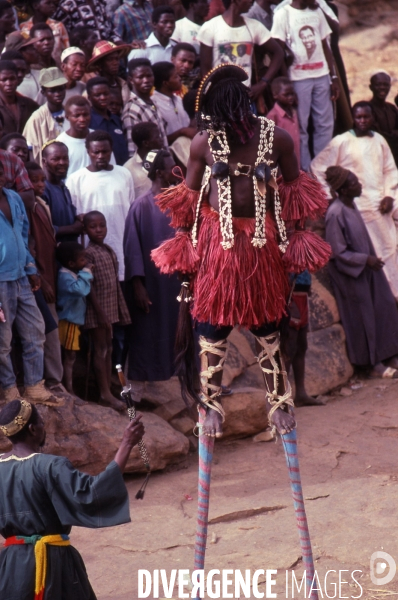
xmin=305 ymin=324 xmax=354 ymax=396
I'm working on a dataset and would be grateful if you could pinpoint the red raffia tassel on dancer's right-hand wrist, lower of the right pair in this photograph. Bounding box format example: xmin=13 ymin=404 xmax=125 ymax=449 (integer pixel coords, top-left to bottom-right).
xmin=283 ymin=231 xmax=332 ymax=273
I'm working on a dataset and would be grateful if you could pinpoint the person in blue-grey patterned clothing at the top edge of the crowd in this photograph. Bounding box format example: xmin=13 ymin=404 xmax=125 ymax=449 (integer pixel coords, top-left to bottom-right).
xmin=113 ymin=0 xmax=152 ymax=44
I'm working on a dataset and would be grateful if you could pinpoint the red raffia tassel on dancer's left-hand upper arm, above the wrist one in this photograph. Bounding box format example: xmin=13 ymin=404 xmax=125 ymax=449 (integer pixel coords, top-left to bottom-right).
xmin=156 ymin=181 xmax=200 ymax=229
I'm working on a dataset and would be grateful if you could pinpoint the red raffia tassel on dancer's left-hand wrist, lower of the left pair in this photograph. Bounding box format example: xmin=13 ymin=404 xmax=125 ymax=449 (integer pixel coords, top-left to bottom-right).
xmin=151 ymin=231 xmax=199 ymax=275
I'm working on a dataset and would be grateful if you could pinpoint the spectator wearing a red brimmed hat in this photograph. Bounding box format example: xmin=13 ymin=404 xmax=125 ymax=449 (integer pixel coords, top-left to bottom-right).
xmin=87 ymin=41 xmax=130 ymax=103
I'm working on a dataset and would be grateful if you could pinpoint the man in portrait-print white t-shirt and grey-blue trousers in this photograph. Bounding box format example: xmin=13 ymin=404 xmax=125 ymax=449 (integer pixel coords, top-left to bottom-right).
xmin=272 ymin=0 xmax=339 ymax=171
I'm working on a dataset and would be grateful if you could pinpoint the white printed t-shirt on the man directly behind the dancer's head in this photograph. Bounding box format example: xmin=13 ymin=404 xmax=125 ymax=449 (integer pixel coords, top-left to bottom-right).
xmin=197 ymin=15 xmax=271 ymax=86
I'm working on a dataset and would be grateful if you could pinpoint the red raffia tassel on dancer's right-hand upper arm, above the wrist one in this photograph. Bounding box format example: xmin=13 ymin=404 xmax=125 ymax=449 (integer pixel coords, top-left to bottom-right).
xmin=278 ymin=171 xmax=329 ymax=225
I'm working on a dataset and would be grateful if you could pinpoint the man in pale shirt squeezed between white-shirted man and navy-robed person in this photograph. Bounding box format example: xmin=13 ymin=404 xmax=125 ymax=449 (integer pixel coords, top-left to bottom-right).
xmin=124 ymin=122 xmax=163 ymax=198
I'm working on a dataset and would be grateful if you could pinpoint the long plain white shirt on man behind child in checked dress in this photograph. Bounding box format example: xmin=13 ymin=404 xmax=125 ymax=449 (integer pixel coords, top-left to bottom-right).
xmin=66 ymin=165 xmax=134 ymax=281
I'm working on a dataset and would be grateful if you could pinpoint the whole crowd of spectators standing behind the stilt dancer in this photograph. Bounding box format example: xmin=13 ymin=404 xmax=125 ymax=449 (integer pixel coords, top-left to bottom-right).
xmin=0 ymin=0 xmax=398 ymax=418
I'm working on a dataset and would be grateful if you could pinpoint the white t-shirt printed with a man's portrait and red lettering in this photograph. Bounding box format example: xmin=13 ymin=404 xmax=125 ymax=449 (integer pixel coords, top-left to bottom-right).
xmin=271 ymin=5 xmax=332 ymax=81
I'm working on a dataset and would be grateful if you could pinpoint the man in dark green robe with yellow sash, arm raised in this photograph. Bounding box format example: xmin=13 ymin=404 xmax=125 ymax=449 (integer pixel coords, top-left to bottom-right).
xmin=0 ymin=400 xmax=145 ymax=600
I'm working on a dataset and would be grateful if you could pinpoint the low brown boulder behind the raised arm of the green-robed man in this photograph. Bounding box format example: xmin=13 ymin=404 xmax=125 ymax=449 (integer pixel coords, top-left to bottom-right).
xmin=0 ymin=396 xmax=189 ymax=473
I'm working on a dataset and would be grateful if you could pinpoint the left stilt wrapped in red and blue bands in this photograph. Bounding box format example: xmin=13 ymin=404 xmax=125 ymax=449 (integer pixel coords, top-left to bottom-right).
xmin=194 ymin=408 xmax=214 ymax=600
